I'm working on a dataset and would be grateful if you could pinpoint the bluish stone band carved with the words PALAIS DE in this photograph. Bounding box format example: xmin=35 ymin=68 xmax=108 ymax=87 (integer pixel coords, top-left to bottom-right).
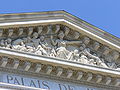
xmin=3 ymin=75 xmax=103 ymax=90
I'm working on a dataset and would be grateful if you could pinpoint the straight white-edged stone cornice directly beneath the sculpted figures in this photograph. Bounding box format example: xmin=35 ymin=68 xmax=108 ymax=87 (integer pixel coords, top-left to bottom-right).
xmin=0 ymin=48 xmax=120 ymax=77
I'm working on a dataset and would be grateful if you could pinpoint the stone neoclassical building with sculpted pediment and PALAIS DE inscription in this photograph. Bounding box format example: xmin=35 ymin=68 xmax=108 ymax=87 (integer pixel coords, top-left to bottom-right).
xmin=0 ymin=11 xmax=120 ymax=90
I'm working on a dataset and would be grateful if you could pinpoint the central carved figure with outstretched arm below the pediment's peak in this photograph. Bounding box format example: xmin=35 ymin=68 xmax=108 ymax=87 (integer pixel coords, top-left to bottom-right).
xmin=51 ymin=31 xmax=82 ymax=60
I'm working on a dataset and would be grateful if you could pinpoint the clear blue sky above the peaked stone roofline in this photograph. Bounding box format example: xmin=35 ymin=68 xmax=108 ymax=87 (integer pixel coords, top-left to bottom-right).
xmin=0 ymin=0 xmax=120 ymax=38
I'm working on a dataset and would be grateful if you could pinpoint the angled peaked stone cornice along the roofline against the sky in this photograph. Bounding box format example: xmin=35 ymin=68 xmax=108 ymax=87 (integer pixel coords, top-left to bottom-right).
xmin=0 ymin=11 xmax=120 ymax=51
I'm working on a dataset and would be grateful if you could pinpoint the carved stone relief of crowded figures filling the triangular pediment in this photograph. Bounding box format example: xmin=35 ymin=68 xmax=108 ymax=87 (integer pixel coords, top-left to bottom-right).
xmin=0 ymin=25 xmax=119 ymax=69
